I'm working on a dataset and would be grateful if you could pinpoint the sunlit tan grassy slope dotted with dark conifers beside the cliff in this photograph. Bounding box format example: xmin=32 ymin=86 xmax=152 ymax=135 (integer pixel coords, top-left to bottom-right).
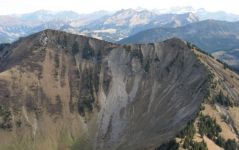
xmin=156 ymin=43 xmax=239 ymax=150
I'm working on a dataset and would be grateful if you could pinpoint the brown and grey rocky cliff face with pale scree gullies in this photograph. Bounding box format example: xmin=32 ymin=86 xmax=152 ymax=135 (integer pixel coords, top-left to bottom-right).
xmin=0 ymin=30 xmax=208 ymax=150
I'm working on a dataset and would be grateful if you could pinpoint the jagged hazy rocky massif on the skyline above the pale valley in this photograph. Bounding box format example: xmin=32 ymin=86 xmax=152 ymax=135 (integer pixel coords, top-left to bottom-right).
xmin=103 ymin=9 xmax=198 ymax=27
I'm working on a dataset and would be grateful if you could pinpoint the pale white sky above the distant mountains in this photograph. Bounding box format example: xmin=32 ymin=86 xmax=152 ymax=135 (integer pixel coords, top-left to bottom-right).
xmin=0 ymin=0 xmax=239 ymax=15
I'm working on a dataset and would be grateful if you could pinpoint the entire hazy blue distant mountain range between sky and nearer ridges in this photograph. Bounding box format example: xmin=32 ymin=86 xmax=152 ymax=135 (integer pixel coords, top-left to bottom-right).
xmin=0 ymin=7 xmax=239 ymax=43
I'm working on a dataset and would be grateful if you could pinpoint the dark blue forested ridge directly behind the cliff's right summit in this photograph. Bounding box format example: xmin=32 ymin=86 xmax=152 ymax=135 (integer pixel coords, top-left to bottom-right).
xmin=120 ymin=20 xmax=239 ymax=52
